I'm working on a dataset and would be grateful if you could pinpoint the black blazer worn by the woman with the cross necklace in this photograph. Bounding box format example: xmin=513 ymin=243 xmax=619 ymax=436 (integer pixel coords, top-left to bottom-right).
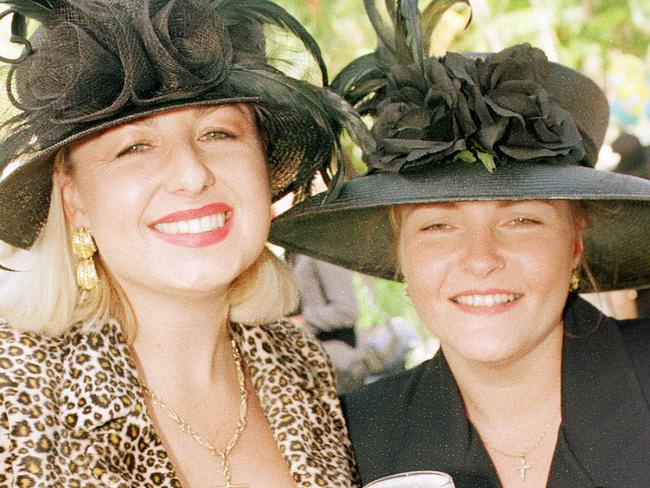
xmin=343 ymin=298 xmax=650 ymax=488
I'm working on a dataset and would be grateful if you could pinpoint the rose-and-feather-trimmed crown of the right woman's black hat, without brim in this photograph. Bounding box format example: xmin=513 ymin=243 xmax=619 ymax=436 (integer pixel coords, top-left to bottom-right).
xmin=333 ymin=0 xmax=609 ymax=172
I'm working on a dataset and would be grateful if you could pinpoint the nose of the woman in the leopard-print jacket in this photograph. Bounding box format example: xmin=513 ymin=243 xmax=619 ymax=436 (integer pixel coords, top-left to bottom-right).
xmin=165 ymin=143 xmax=216 ymax=195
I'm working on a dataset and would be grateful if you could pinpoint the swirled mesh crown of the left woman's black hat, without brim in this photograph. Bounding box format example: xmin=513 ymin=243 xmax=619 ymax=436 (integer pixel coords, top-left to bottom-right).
xmin=9 ymin=0 xmax=253 ymax=130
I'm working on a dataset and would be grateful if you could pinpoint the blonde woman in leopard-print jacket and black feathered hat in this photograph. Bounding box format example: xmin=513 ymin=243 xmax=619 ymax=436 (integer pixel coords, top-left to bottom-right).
xmin=0 ymin=0 xmax=356 ymax=488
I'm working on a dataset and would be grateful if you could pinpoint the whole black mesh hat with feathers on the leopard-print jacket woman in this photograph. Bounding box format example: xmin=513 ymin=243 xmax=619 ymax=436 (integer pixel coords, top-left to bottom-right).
xmin=0 ymin=0 xmax=360 ymax=248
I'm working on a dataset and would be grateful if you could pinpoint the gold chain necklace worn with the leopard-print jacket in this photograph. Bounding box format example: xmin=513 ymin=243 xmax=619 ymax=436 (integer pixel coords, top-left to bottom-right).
xmin=140 ymin=340 xmax=249 ymax=488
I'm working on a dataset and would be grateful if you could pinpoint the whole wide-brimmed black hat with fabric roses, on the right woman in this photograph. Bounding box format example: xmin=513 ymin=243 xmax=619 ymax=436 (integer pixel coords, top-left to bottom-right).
xmin=271 ymin=1 xmax=650 ymax=291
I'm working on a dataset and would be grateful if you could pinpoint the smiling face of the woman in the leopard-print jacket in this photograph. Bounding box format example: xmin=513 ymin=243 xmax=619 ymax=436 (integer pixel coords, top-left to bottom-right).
xmin=57 ymin=105 xmax=271 ymax=298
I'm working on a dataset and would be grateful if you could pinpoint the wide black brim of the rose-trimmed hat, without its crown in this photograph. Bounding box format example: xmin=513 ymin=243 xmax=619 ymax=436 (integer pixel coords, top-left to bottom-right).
xmin=270 ymin=162 xmax=650 ymax=291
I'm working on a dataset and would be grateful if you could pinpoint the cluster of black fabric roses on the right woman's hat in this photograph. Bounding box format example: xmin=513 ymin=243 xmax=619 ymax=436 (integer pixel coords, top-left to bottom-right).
xmin=369 ymin=44 xmax=585 ymax=171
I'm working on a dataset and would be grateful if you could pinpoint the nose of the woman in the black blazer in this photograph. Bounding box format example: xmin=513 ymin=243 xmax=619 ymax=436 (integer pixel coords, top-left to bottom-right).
xmin=462 ymin=227 xmax=505 ymax=278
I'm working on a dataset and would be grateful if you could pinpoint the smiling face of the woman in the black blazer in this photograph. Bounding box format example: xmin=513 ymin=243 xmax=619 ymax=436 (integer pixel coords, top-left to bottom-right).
xmin=398 ymin=200 xmax=583 ymax=362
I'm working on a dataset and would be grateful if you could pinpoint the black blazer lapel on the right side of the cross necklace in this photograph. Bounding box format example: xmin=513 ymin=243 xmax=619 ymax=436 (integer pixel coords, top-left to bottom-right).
xmin=548 ymin=300 xmax=650 ymax=488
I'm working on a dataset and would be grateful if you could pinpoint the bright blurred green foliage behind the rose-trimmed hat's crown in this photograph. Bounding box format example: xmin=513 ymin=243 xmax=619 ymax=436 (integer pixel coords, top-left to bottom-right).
xmin=277 ymin=0 xmax=650 ymax=137
